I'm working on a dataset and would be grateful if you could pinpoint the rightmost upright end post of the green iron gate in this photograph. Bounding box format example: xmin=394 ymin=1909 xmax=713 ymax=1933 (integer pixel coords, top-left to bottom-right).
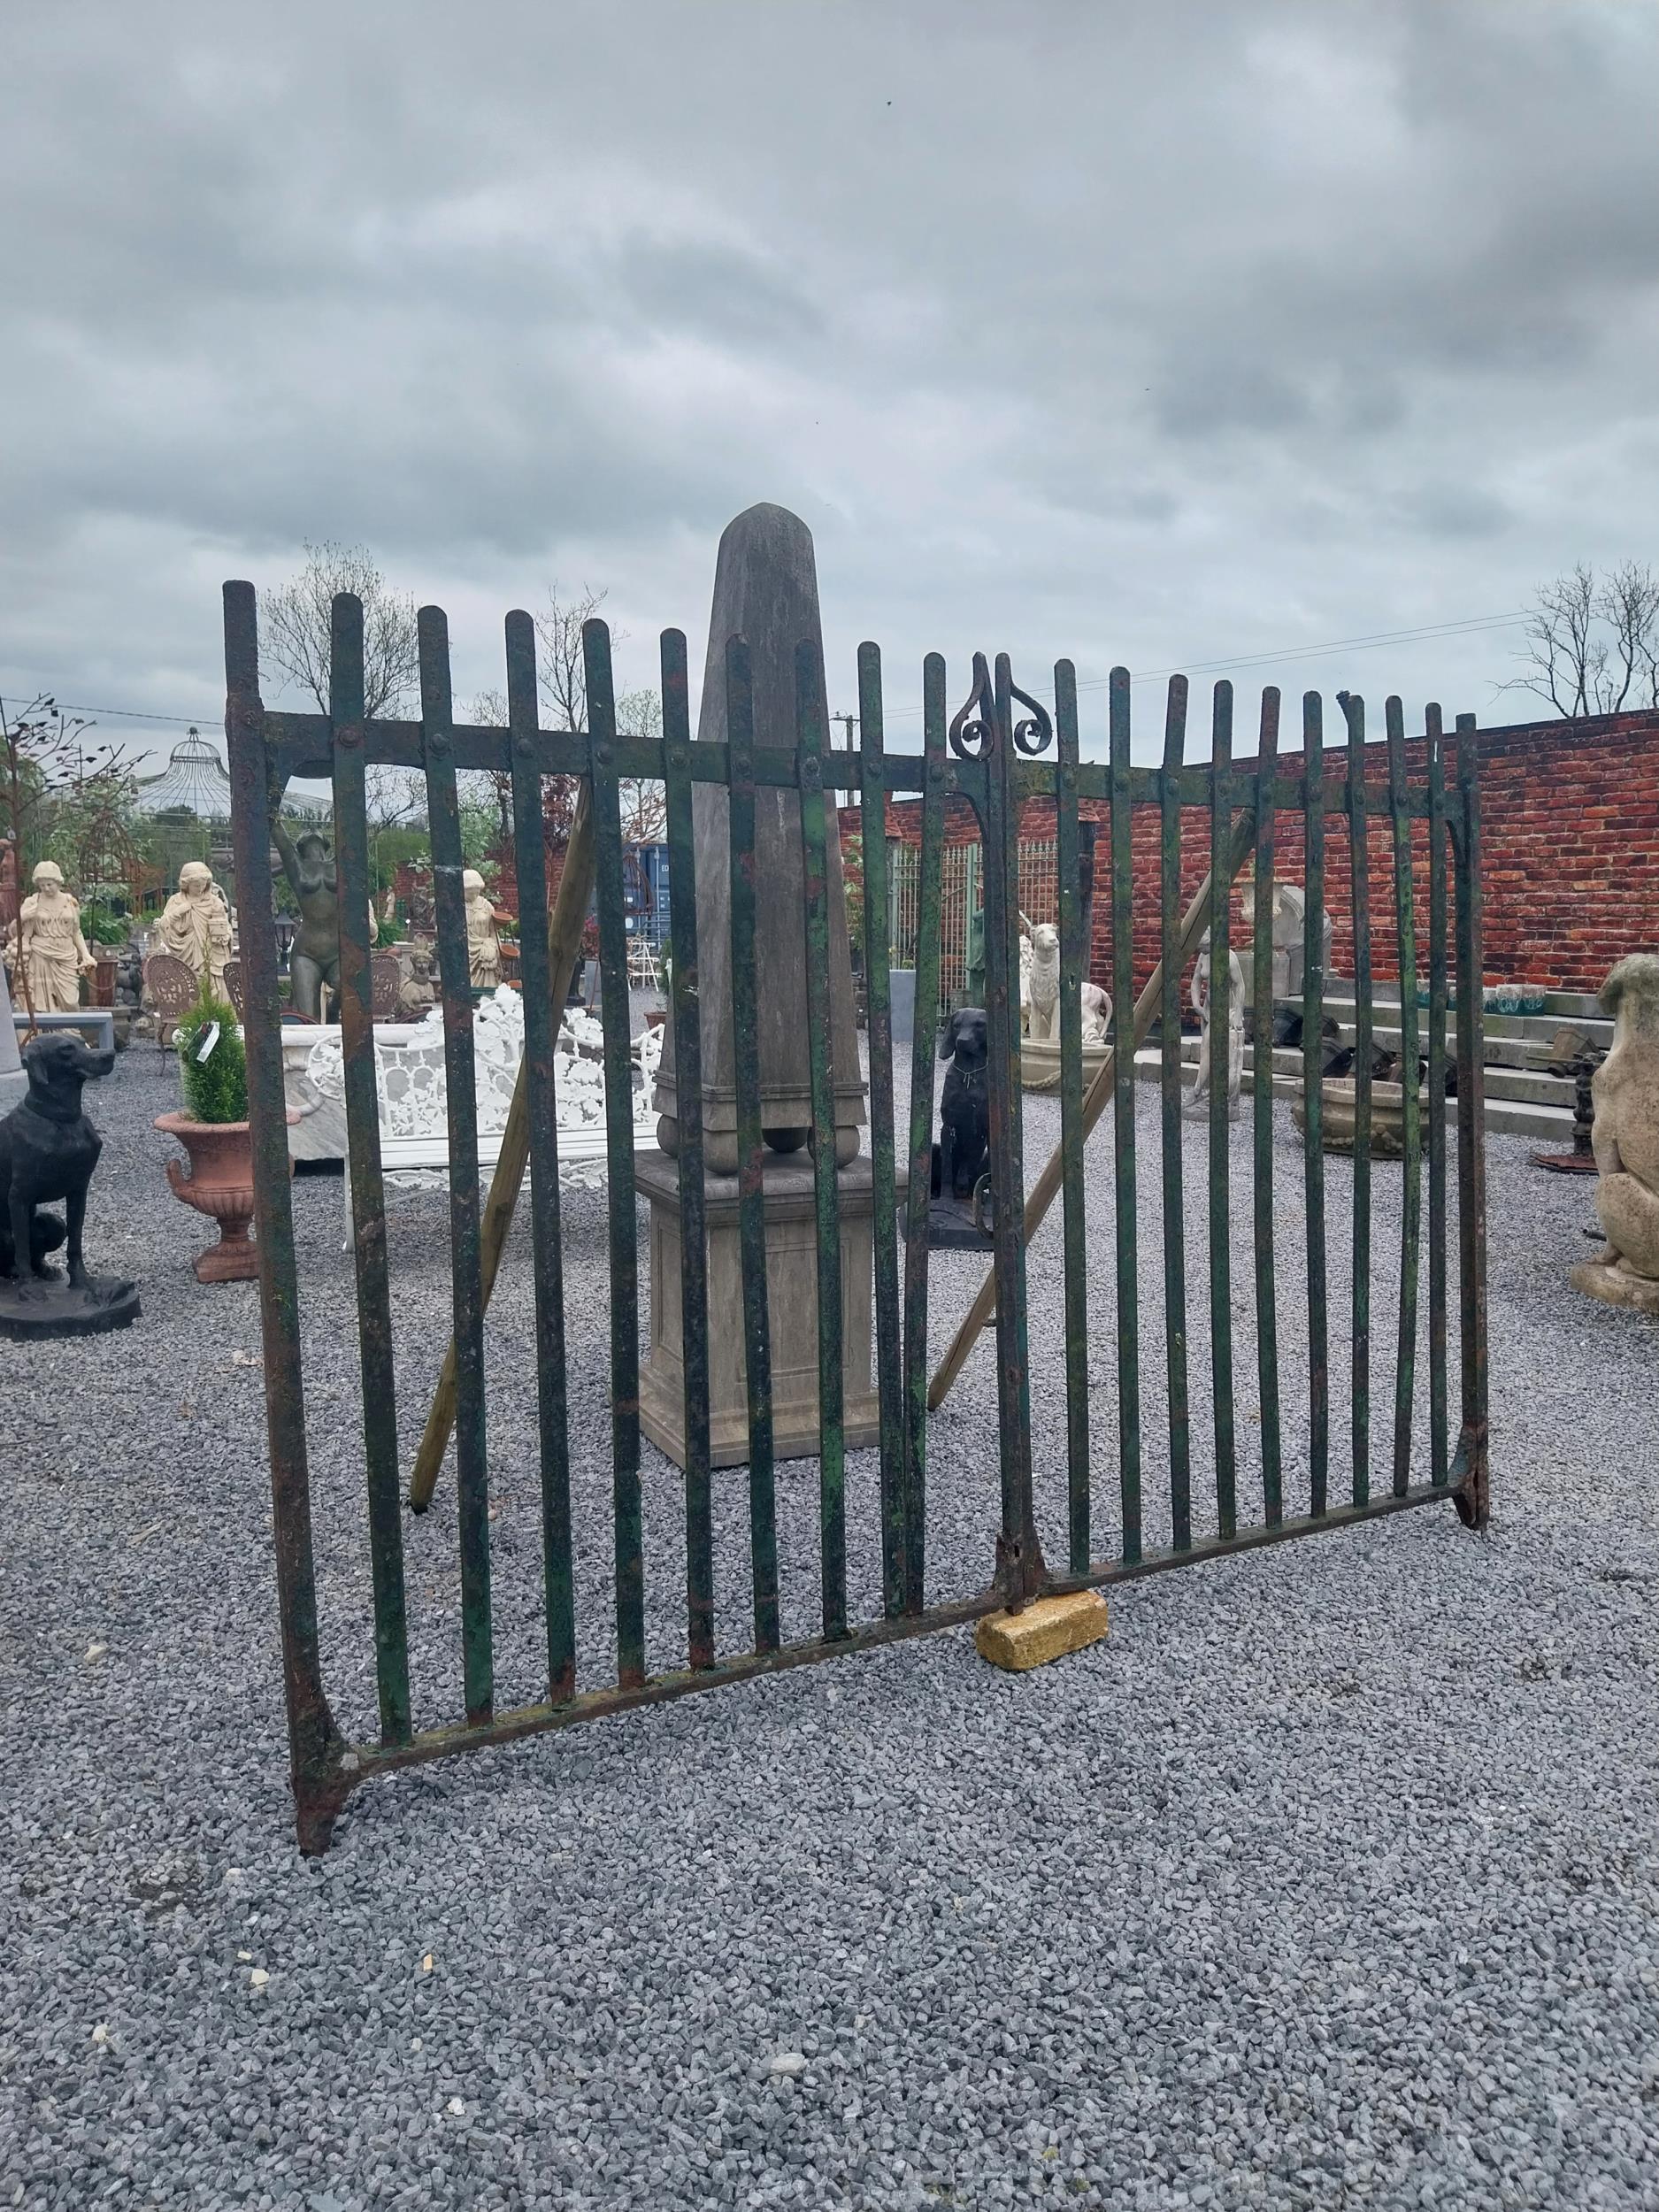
xmin=1458 ymin=715 xmax=1489 ymax=1529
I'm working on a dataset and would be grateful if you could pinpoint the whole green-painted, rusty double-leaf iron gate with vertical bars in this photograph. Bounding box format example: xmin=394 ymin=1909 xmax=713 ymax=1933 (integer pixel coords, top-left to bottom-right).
xmin=224 ymin=584 xmax=1486 ymax=1852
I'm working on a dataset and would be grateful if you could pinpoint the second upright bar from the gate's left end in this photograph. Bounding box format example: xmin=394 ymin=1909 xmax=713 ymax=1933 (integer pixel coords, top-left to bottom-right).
xmin=327 ymin=591 xmax=410 ymax=1743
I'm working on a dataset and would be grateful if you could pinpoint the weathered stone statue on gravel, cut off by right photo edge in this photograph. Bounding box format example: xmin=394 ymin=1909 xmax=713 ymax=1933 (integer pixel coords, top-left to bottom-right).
xmin=1571 ymin=954 xmax=1659 ymax=1314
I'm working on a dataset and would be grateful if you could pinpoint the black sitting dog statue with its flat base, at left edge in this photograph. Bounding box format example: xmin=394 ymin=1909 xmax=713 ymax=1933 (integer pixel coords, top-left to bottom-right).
xmin=0 ymin=1031 xmax=140 ymax=1336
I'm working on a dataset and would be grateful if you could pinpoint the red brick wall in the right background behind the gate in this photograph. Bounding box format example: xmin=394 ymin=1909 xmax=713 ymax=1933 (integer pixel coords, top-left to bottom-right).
xmin=858 ymin=712 xmax=1659 ymax=991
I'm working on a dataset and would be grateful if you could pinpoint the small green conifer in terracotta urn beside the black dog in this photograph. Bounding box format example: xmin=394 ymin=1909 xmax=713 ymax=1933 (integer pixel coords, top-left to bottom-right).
xmin=155 ymin=976 xmax=299 ymax=1283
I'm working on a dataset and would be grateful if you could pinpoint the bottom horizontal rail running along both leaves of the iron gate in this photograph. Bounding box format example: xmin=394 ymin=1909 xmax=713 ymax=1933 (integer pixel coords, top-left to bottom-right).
xmin=325 ymin=1458 xmax=1469 ymax=1787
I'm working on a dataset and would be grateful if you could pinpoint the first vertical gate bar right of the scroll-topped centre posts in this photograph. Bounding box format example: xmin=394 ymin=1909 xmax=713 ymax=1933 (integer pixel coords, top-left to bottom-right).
xmin=1056 ymin=662 xmax=1088 ymax=1575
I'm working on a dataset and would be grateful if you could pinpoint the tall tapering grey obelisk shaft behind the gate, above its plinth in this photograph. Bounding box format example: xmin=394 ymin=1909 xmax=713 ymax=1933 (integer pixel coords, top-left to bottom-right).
xmin=657 ymin=507 xmax=865 ymax=1175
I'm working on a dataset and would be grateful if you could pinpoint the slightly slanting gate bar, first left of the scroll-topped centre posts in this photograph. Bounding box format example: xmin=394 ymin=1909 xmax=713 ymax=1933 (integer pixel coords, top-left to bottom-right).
xmin=905 ymin=653 xmax=947 ymax=1613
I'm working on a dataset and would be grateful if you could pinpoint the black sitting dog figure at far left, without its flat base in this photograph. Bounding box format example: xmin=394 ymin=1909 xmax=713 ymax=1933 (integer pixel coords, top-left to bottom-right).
xmin=0 ymin=1031 xmax=131 ymax=1301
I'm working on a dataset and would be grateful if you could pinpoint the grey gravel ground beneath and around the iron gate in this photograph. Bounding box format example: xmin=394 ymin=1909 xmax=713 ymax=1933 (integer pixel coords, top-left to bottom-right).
xmin=0 ymin=1047 xmax=1659 ymax=2212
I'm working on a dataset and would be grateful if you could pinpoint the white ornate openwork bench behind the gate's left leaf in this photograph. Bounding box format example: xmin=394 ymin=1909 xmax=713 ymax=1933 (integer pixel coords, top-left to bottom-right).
xmin=305 ymin=989 xmax=662 ymax=1250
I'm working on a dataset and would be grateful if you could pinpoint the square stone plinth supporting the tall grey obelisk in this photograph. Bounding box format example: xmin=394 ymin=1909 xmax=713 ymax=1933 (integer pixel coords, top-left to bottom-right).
xmin=635 ymin=1153 xmax=902 ymax=1467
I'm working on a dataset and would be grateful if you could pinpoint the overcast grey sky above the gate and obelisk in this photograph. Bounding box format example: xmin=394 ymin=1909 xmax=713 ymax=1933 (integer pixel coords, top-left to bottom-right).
xmin=0 ymin=0 xmax=1659 ymax=770
